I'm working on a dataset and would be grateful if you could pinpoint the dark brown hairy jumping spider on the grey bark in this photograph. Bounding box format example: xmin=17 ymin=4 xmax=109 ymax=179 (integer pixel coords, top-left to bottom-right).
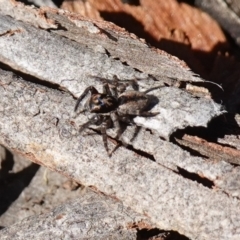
xmin=74 ymin=76 xmax=159 ymax=156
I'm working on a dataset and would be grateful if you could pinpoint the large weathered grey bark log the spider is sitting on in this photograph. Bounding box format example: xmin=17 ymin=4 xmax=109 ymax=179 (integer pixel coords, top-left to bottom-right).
xmin=0 ymin=0 xmax=240 ymax=239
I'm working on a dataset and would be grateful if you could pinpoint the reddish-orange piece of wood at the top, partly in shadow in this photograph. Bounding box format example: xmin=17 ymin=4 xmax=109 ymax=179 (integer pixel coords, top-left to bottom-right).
xmin=61 ymin=0 xmax=229 ymax=77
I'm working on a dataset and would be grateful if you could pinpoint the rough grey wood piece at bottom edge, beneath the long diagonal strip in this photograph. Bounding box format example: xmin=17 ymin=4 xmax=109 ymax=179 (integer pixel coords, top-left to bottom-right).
xmin=0 ymin=183 xmax=145 ymax=240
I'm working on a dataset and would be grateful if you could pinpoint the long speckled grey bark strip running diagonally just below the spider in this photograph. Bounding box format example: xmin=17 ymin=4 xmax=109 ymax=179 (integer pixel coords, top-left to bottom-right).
xmin=0 ymin=71 xmax=240 ymax=239
